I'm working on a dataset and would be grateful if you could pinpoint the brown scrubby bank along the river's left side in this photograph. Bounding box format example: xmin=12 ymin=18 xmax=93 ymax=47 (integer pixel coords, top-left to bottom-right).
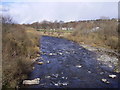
xmin=2 ymin=23 xmax=40 ymax=88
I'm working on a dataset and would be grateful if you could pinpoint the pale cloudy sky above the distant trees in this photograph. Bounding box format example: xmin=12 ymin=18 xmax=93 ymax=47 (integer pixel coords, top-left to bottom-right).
xmin=0 ymin=0 xmax=118 ymax=24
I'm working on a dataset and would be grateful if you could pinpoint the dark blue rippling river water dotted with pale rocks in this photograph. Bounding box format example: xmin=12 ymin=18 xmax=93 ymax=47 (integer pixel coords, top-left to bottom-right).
xmin=27 ymin=36 xmax=118 ymax=88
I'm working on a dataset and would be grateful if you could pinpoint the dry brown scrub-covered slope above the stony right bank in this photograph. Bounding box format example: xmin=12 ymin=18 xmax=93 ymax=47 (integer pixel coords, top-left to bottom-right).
xmin=65 ymin=20 xmax=119 ymax=50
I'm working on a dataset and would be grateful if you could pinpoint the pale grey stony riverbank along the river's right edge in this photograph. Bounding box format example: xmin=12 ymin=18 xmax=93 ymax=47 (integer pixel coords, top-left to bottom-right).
xmin=80 ymin=44 xmax=120 ymax=73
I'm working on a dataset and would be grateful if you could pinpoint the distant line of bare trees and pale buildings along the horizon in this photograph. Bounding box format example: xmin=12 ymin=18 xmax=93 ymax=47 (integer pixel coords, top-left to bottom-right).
xmin=23 ymin=18 xmax=117 ymax=30
